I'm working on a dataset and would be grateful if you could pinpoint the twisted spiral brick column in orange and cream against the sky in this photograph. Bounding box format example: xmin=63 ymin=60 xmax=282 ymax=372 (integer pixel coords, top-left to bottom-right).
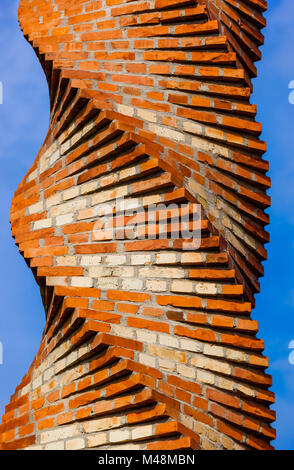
xmin=0 ymin=0 xmax=275 ymax=450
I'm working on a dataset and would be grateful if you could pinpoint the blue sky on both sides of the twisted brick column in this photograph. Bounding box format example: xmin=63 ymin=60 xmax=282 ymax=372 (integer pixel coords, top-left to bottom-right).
xmin=0 ymin=0 xmax=294 ymax=450
